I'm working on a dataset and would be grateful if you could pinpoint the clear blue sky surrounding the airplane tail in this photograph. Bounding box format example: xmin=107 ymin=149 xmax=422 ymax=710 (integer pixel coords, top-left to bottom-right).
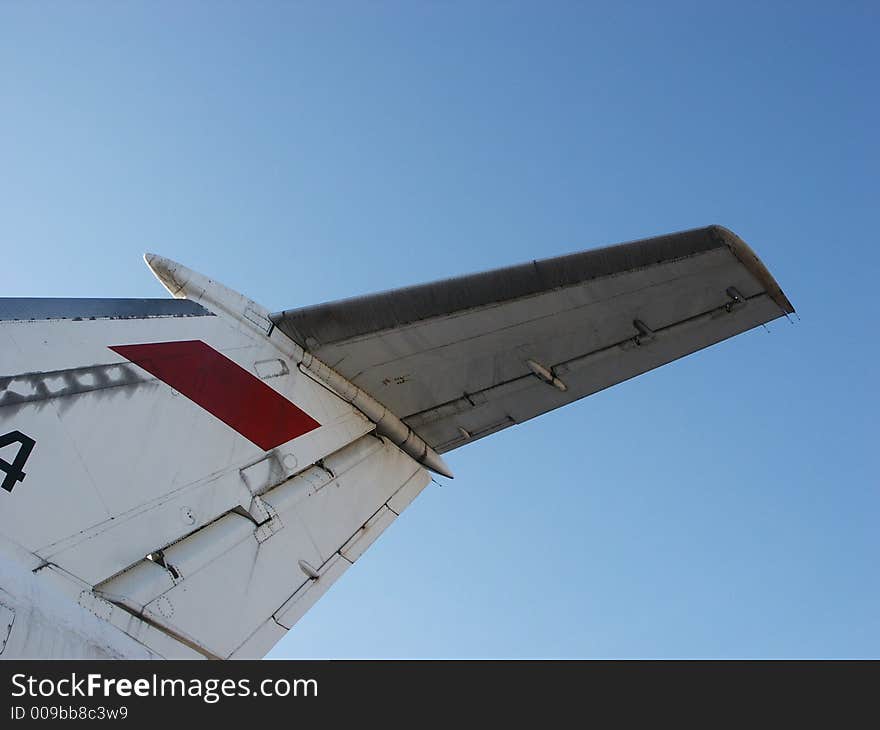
xmin=0 ymin=0 xmax=880 ymax=657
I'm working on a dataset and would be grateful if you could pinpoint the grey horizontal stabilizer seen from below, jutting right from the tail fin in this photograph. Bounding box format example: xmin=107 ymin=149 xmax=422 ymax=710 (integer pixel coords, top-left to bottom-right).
xmin=272 ymin=226 xmax=794 ymax=453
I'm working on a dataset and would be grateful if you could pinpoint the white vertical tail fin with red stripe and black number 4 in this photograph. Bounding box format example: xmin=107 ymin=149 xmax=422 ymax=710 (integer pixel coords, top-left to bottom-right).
xmin=0 ymin=278 xmax=428 ymax=657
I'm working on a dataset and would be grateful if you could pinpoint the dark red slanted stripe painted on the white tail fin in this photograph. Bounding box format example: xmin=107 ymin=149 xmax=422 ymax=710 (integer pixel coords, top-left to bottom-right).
xmin=110 ymin=340 xmax=321 ymax=451
